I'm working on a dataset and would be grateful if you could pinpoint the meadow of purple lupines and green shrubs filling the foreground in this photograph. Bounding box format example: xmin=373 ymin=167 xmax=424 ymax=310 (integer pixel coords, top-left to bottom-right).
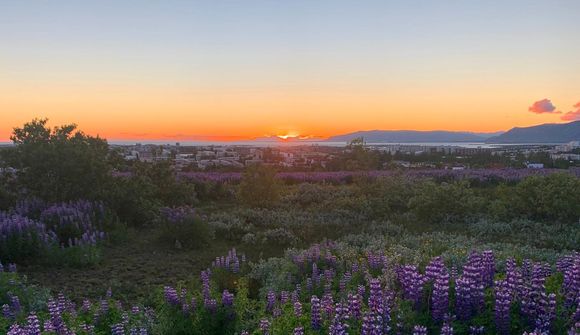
xmin=0 ymin=120 xmax=580 ymax=335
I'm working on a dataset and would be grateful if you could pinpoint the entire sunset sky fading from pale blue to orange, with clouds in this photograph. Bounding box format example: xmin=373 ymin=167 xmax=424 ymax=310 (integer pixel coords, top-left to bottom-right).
xmin=0 ymin=0 xmax=580 ymax=141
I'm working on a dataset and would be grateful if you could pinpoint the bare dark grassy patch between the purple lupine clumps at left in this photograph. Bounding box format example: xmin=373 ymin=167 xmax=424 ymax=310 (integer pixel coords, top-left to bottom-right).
xmin=19 ymin=228 xmax=232 ymax=302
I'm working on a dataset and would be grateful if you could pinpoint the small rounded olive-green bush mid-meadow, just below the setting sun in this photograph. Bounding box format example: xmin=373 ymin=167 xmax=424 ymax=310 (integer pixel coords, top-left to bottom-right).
xmin=238 ymin=165 xmax=280 ymax=207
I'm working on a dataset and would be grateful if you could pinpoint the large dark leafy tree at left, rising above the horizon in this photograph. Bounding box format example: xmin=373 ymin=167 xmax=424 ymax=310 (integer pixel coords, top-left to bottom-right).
xmin=5 ymin=119 xmax=111 ymax=201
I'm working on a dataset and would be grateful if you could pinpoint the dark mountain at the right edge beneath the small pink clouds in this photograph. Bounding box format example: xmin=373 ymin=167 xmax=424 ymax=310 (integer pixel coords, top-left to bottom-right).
xmin=486 ymin=121 xmax=580 ymax=143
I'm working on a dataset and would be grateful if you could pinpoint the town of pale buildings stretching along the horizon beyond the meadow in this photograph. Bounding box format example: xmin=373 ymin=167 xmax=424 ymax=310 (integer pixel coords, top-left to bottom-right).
xmin=112 ymin=141 xmax=580 ymax=172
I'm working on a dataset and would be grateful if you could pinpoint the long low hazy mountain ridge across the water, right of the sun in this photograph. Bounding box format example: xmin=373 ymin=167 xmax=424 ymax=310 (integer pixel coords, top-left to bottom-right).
xmin=327 ymin=130 xmax=498 ymax=143
